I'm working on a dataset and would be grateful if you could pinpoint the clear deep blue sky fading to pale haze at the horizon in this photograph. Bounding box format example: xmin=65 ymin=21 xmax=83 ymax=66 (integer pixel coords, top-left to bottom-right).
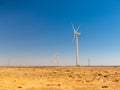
xmin=0 ymin=0 xmax=120 ymax=65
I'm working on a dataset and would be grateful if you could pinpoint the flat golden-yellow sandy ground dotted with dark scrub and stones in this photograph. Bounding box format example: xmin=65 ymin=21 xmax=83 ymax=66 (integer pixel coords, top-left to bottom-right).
xmin=0 ymin=66 xmax=120 ymax=90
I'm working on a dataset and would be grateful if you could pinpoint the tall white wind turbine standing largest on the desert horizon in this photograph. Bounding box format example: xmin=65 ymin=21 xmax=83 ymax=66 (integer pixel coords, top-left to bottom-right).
xmin=72 ymin=25 xmax=80 ymax=66
